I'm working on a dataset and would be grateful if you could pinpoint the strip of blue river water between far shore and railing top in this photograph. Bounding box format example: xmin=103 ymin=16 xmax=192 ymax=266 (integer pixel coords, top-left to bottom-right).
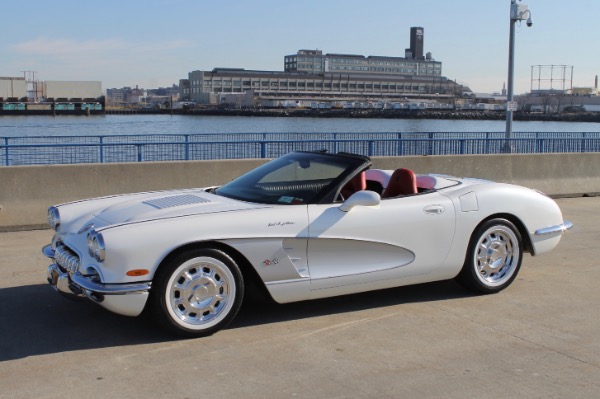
xmin=0 ymin=115 xmax=600 ymax=137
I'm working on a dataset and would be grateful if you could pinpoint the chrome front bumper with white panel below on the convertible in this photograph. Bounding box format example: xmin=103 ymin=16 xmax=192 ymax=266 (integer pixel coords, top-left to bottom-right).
xmin=42 ymin=245 xmax=152 ymax=316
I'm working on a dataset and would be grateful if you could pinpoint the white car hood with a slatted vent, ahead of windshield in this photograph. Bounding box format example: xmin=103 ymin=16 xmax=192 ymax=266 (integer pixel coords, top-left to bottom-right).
xmin=92 ymin=189 xmax=269 ymax=226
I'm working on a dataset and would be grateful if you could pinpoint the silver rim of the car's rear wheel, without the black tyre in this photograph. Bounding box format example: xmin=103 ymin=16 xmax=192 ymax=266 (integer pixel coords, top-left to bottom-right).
xmin=474 ymin=225 xmax=520 ymax=286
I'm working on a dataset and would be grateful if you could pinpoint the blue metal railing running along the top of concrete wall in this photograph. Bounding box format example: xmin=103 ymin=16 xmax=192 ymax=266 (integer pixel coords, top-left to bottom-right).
xmin=0 ymin=132 xmax=600 ymax=166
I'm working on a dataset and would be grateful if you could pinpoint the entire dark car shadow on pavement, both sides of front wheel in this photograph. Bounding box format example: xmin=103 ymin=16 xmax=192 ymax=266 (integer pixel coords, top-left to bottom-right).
xmin=0 ymin=281 xmax=472 ymax=362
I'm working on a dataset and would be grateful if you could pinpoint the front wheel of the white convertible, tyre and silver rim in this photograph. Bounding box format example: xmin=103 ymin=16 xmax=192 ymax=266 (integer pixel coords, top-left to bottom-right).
xmin=151 ymin=249 xmax=244 ymax=337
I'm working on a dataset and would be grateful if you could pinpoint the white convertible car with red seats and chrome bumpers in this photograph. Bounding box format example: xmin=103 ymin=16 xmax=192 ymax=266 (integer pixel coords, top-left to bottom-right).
xmin=43 ymin=152 xmax=572 ymax=336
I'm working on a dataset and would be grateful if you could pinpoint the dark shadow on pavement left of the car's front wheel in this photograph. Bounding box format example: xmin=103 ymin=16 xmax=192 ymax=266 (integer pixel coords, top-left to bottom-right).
xmin=0 ymin=284 xmax=175 ymax=361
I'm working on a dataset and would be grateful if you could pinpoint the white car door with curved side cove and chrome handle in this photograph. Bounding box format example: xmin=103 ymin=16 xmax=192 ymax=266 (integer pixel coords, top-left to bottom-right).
xmin=308 ymin=192 xmax=455 ymax=297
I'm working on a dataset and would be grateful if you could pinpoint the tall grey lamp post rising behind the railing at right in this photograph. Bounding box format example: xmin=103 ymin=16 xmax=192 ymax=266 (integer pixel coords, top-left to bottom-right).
xmin=504 ymin=0 xmax=533 ymax=152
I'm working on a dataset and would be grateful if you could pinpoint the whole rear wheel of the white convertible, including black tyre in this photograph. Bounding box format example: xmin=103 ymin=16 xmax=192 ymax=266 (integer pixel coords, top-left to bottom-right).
xmin=457 ymin=219 xmax=523 ymax=294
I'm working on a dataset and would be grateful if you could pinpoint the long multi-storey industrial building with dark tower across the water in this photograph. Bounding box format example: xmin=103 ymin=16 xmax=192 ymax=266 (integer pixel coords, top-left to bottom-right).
xmin=179 ymin=27 xmax=463 ymax=105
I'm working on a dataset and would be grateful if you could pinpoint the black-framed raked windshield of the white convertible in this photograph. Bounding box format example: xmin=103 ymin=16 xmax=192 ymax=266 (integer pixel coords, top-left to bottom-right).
xmin=215 ymin=152 xmax=368 ymax=205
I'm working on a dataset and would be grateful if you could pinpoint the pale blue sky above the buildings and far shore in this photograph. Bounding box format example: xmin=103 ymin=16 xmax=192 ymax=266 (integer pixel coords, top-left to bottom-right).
xmin=0 ymin=0 xmax=600 ymax=94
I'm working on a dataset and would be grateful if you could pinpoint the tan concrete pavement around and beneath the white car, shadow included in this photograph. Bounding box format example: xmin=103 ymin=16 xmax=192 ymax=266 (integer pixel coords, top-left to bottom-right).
xmin=0 ymin=197 xmax=600 ymax=398
